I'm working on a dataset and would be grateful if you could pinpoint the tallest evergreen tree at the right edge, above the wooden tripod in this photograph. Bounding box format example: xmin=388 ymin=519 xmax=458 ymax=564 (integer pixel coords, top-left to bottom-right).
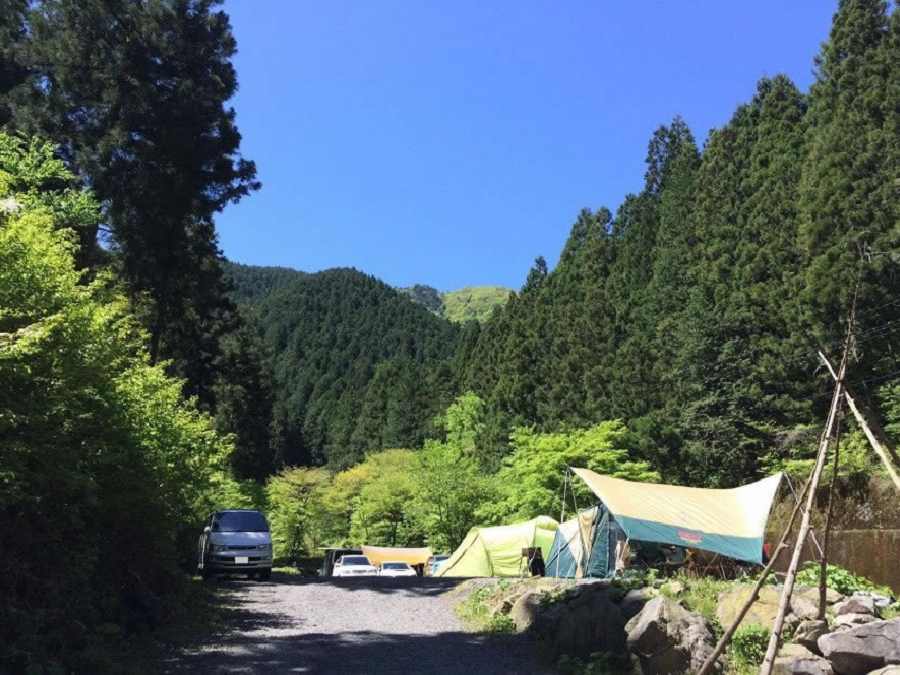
xmin=800 ymin=0 xmax=900 ymax=369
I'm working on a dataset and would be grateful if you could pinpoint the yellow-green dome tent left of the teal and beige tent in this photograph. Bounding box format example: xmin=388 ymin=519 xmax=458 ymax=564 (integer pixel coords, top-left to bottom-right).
xmin=435 ymin=516 xmax=559 ymax=577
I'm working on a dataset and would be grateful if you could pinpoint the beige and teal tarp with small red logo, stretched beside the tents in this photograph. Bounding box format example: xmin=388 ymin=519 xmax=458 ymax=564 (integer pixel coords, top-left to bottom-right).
xmin=573 ymin=469 xmax=782 ymax=563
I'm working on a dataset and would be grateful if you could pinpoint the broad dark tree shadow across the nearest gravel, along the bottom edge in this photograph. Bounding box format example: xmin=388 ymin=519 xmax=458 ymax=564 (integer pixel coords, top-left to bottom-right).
xmin=164 ymin=631 xmax=549 ymax=675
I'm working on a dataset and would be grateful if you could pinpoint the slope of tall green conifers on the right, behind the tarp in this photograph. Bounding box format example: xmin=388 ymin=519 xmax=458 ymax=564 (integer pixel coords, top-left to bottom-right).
xmin=463 ymin=0 xmax=900 ymax=485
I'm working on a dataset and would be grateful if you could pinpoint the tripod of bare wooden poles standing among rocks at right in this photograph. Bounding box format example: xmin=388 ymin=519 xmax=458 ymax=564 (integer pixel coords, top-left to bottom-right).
xmin=699 ymin=294 xmax=900 ymax=675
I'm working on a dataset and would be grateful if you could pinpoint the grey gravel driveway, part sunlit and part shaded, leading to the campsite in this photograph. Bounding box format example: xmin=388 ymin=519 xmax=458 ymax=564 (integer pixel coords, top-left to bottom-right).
xmin=164 ymin=575 xmax=546 ymax=675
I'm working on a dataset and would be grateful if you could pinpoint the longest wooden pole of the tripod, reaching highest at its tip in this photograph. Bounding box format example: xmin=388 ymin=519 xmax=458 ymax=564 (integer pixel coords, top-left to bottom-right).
xmin=759 ymin=334 xmax=855 ymax=675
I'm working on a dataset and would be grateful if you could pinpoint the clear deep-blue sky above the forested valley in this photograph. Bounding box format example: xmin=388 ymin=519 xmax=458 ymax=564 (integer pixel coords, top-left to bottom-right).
xmin=217 ymin=0 xmax=836 ymax=290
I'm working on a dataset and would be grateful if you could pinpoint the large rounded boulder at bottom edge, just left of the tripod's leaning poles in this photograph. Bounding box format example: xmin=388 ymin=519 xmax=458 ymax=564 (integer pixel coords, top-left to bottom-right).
xmin=625 ymin=597 xmax=715 ymax=675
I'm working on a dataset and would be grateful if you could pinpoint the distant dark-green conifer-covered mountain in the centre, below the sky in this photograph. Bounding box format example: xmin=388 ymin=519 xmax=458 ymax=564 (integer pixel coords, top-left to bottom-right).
xmin=228 ymin=265 xmax=459 ymax=467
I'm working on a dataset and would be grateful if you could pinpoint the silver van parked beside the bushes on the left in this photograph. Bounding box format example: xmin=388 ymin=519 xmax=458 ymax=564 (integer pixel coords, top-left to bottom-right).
xmin=197 ymin=509 xmax=272 ymax=579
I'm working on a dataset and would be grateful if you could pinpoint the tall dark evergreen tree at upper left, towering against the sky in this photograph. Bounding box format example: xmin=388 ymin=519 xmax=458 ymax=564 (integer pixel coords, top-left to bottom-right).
xmin=14 ymin=0 xmax=259 ymax=401
